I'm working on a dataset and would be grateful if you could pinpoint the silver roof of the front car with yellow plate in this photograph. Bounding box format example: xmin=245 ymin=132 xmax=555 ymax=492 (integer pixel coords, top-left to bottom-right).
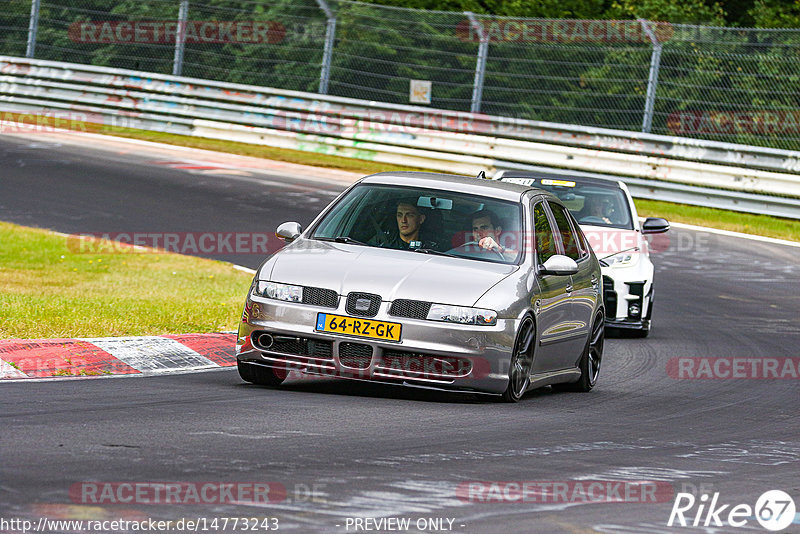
xmin=359 ymin=171 xmax=551 ymax=202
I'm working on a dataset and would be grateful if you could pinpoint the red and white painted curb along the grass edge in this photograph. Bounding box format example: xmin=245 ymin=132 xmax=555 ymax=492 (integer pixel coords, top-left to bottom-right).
xmin=0 ymin=333 xmax=236 ymax=380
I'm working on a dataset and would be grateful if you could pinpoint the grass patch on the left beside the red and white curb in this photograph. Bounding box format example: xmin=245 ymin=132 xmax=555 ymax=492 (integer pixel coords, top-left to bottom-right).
xmin=0 ymin=222 xmax=252 ymax=339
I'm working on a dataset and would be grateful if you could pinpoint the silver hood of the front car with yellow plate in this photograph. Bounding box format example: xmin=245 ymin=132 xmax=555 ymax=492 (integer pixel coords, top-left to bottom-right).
xmin=259 ymin=239 xmax=519 ymax=306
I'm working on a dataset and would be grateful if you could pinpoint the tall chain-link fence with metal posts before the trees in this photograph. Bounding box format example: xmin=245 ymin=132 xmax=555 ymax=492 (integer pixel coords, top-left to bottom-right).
xmin=0 ymin=0 xmax=800 ymax=149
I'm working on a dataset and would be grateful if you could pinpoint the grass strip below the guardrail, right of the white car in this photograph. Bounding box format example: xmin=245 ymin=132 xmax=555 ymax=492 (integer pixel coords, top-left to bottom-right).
xmin=636 ymin=199 xmax=800 ymax=241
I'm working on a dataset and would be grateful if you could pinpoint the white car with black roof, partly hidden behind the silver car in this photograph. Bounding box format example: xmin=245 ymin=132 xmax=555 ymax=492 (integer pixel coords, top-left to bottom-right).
xmin=493 ymin=171 xmax=669 ymax=337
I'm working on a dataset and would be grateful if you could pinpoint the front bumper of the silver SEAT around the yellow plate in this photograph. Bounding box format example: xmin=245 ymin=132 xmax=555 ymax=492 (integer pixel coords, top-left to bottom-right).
xmin=236 ymin=295 xmax=518 ymax=394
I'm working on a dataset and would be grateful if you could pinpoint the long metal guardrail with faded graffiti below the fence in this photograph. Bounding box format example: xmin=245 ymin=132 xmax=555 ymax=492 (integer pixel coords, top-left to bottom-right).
xmin=0 ymin=56 xmax=800 ymax=219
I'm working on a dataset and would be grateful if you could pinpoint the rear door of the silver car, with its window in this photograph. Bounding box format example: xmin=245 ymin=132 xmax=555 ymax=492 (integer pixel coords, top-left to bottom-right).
xmin=548 ymin=201 xmax=599 ymax=366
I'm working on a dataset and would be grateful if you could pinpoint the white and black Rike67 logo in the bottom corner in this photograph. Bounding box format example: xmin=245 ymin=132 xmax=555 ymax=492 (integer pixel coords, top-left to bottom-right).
xmin=667 ymin=490 xmax=797 ymax=532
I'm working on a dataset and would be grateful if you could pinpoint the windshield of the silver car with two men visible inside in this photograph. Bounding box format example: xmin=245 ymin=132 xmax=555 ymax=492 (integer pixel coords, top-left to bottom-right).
xmin=311 ymin=184 xmax=522 ymax=263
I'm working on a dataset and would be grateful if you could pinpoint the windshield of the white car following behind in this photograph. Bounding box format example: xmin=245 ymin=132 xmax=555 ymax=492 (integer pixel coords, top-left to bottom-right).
xmin=533 ymin=179 xmax=633 ymax=230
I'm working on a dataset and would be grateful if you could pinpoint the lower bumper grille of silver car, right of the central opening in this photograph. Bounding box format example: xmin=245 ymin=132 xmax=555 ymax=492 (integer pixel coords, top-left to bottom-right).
xmin=375 ymin=350 xmax=472 ymax=382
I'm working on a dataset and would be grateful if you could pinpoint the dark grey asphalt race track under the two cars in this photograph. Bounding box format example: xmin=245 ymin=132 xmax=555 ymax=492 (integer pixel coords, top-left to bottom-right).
xmin=0 ymin=131 xmax=800 ymax=533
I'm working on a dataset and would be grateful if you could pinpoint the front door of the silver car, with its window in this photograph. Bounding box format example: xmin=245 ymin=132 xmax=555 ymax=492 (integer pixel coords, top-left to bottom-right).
xmin=532 ymin=201 xmax=572 ymax=374
